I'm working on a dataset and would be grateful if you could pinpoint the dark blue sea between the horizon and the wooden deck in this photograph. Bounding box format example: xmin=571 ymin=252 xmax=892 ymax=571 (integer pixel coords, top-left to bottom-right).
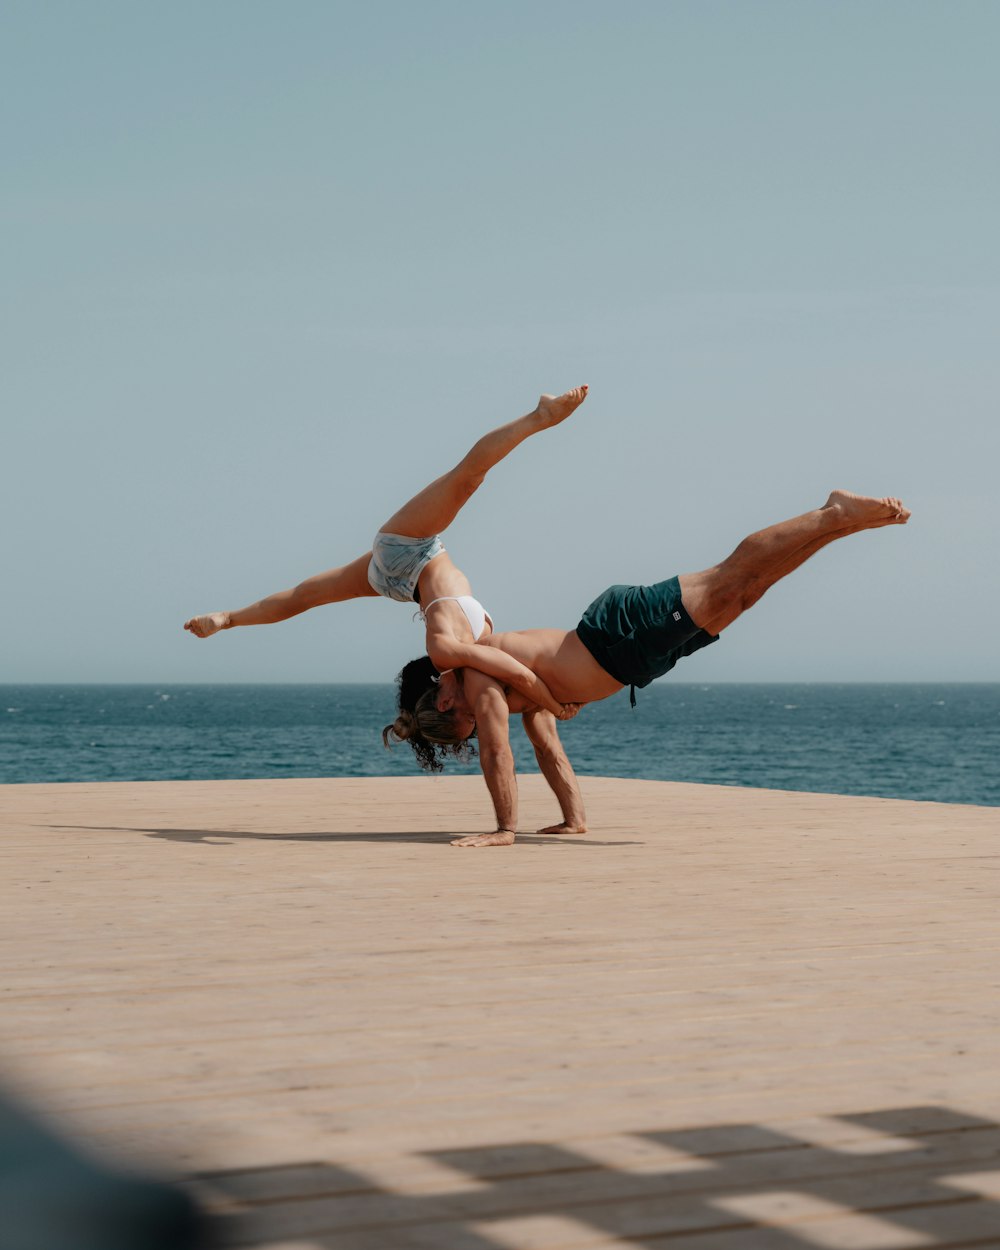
xmin=0 ymin=681 xmax=1000 ymax=806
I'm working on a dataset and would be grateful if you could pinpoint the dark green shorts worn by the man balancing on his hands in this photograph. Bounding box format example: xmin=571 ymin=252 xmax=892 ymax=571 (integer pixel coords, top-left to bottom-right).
xmin=576 ymin=578 xmax=719 ymax=704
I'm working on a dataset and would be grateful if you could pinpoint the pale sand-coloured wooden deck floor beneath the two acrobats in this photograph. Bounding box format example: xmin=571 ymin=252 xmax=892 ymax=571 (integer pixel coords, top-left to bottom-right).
xmin=0 ymin=778 xmax=1000 ymax=1250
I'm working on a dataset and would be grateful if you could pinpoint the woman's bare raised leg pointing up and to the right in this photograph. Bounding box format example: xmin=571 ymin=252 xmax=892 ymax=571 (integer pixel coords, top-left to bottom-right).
xmin=383 ymin=386 xmax=588 ymax=539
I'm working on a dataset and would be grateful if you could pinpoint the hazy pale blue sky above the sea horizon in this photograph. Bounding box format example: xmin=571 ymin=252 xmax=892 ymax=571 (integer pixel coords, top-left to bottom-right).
xmin=0 ymin=0 xmax=1000 ymax=683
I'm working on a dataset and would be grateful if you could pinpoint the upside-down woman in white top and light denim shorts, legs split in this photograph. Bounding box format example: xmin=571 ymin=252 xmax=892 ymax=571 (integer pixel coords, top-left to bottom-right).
xmin=184 ymin=386 xmax=588 ymax=769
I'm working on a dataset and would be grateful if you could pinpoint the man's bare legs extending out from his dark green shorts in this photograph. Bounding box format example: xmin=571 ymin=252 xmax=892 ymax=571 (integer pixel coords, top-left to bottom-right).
xmin=680 ymin=490 xmax=910 ymax=634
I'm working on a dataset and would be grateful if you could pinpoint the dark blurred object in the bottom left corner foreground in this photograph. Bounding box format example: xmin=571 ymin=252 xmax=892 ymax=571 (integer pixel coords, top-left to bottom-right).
xmin=0 ymin=1094 xmax=208 ymax=1250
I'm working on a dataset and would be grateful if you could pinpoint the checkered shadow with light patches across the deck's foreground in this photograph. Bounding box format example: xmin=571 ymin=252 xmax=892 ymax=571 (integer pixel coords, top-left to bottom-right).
xmin=199 ymin=1106 xmax=1000 ymax=1250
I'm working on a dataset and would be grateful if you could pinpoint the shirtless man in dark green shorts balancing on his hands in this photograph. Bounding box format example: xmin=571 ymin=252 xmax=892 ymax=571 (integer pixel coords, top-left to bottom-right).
xmin=388 ymin=490 xmax=910 ymax=846
